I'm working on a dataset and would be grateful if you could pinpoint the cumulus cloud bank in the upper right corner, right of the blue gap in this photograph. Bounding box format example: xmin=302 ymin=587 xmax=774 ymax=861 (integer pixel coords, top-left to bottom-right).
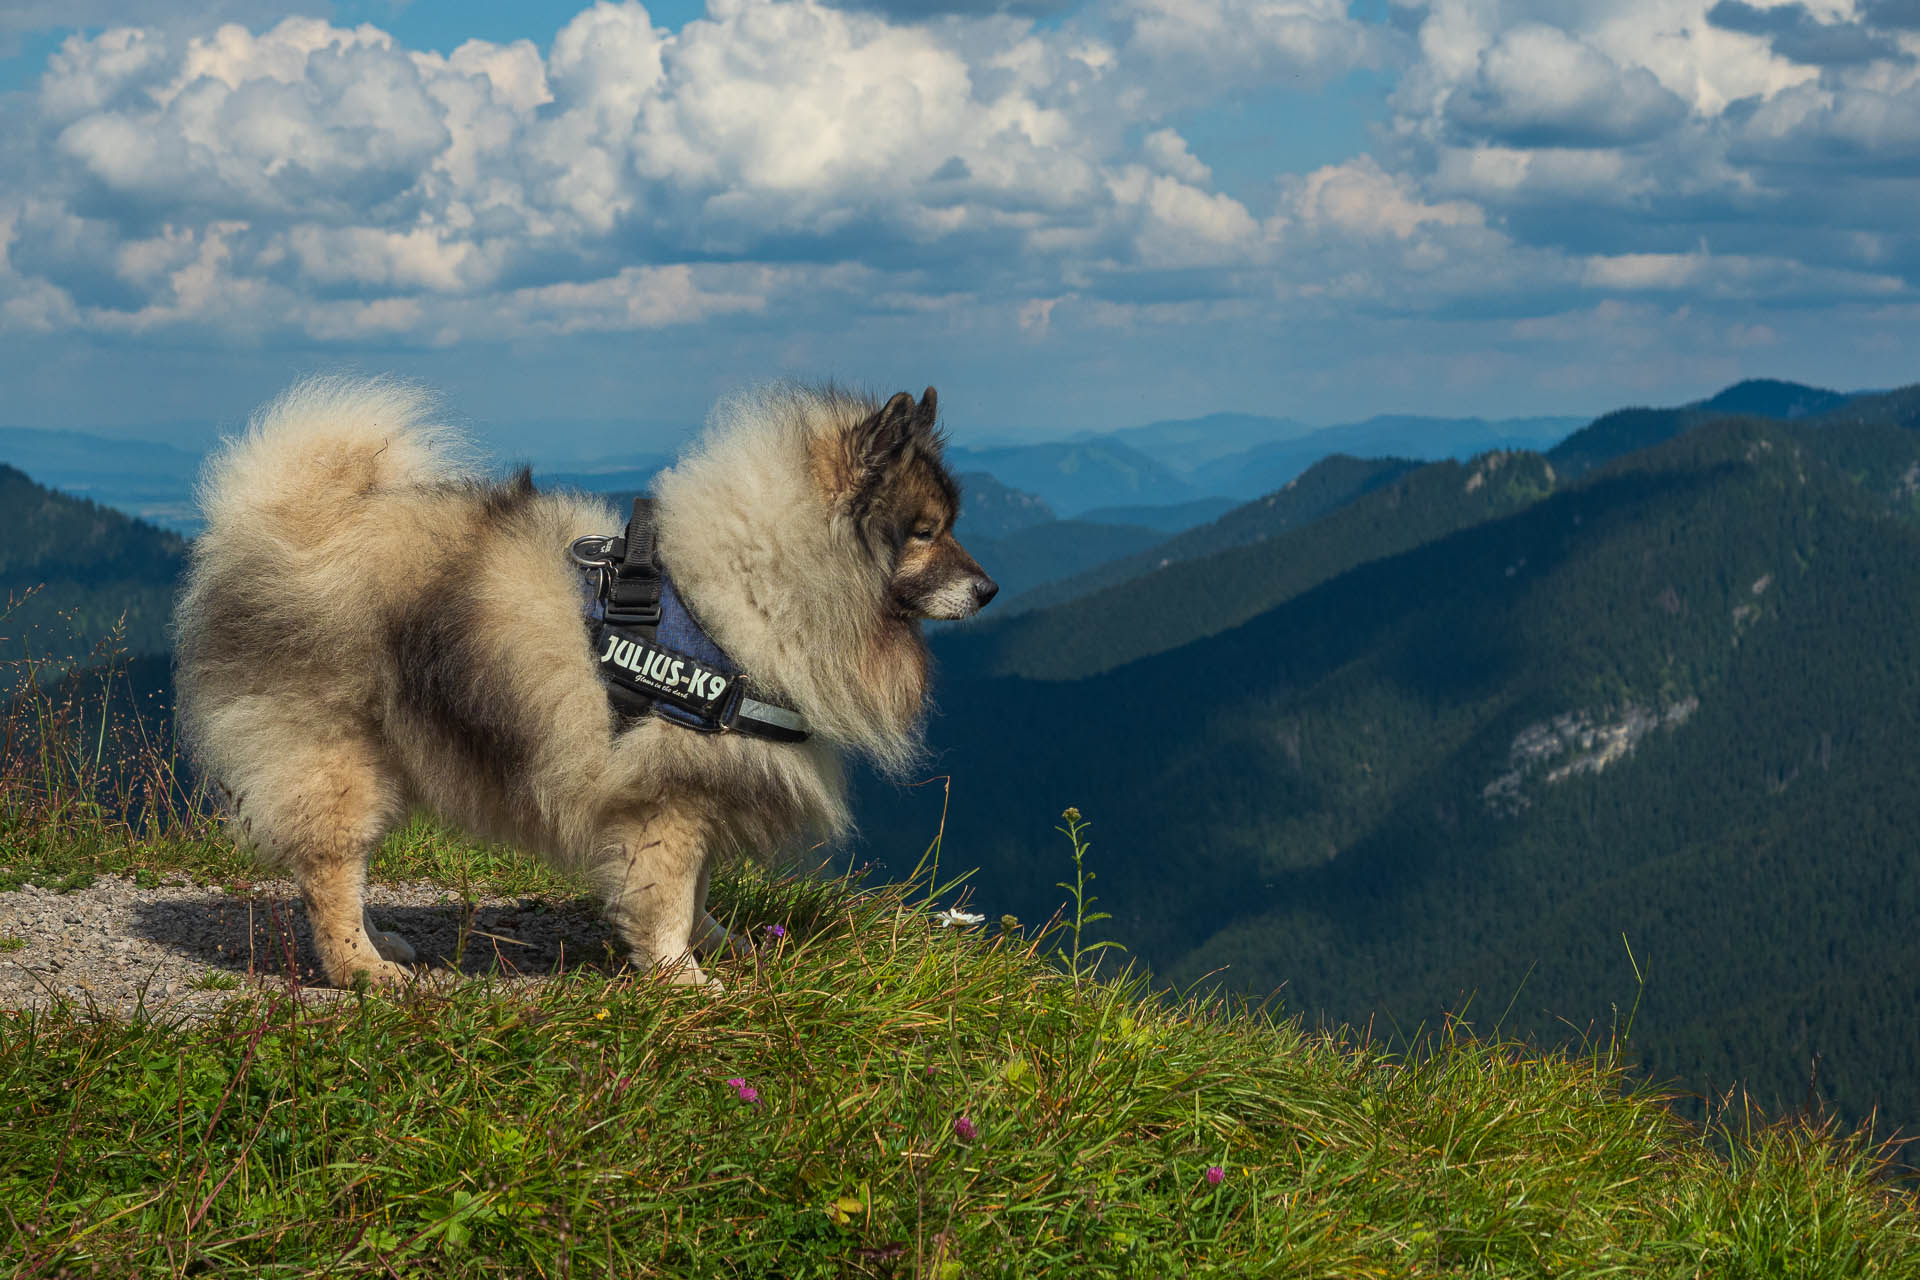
xmin=1382 ymin=0 xmax=1920 ymax=278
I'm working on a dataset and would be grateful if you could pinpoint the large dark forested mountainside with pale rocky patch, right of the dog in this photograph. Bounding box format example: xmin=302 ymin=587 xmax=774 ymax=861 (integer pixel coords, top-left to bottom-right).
xmin=862 ymin=395 xmax=1920 ymax=1143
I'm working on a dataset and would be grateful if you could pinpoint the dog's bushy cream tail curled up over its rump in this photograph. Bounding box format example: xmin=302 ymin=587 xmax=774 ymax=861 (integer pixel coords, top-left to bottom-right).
xmin=198 ymin=376 xmax=467 ymax=537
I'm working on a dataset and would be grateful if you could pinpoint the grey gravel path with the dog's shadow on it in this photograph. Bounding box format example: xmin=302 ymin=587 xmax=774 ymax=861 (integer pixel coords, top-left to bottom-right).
xmin=0 ymin=875 xmax=618 ymax=1021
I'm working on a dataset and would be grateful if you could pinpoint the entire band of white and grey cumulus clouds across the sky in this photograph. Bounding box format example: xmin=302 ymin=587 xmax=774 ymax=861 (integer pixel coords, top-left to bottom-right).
xmin=0 ymin=0 xmax=1920 ymax=370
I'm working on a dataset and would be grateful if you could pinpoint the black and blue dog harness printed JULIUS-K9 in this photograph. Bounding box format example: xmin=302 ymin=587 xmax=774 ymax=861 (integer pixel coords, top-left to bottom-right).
xmin=568 ymin=497 xmax=812 ymax=743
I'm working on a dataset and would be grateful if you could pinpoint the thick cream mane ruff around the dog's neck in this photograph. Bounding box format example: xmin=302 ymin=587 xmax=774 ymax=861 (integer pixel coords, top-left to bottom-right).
xmin=655 ymin=384 xmax=925 ymax=775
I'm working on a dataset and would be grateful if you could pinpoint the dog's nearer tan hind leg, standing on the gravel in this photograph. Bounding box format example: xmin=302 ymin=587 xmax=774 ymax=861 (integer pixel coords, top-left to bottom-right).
xmin=234 ymin=727 xmax=413 ymax=986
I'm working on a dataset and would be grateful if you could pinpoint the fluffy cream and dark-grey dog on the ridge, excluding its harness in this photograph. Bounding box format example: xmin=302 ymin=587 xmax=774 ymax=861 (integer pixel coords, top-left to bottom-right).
xmin=175 ymin=378 xmax=996 ymax=986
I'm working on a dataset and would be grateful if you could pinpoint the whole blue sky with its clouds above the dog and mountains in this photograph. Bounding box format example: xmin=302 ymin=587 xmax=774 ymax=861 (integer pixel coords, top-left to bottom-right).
xmin=0 ymin=0 xmax=1920 ymax=461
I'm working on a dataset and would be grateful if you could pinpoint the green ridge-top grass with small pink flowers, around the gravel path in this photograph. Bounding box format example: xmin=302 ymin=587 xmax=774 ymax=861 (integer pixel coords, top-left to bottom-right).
xmin=11 ymin=629 xmax=1920 ymax=1280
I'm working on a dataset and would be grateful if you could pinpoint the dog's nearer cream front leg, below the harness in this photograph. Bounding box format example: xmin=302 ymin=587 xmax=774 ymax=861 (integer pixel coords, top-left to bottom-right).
xmin=591 ymin=808 xmax=726 ymax=990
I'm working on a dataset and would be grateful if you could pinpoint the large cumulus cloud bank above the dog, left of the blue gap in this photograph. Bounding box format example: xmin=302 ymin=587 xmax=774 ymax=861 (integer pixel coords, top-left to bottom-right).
xmin=0 ymin=0 xmax=1397 ymax=342
